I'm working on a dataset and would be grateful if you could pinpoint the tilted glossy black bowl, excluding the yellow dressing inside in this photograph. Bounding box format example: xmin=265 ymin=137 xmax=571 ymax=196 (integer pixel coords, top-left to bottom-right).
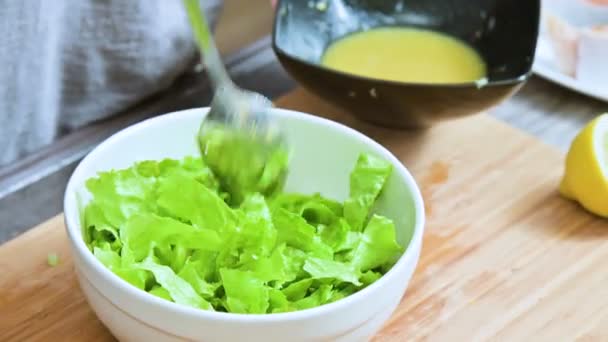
xmin=273 ymin=0 xmax=540 ymax=127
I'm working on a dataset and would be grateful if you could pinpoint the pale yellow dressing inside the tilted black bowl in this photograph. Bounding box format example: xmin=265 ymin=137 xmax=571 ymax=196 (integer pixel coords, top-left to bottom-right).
xmin=321 ymin=28 xmax=486 ymax=83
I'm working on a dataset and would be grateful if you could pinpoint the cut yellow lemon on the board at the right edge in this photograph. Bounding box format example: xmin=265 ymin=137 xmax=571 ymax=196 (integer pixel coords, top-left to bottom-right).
xmin=559 ymin=113 xmax=608 ymax=217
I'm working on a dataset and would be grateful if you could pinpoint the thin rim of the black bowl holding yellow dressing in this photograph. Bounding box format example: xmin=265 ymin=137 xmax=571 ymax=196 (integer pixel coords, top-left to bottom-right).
xmin=270 ymin=0 xmax=541 ymax=90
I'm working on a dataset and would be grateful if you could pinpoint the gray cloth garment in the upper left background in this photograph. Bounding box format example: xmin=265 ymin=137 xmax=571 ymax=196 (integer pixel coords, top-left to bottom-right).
xmin=0 ymin=0 xmax=221 ymax=166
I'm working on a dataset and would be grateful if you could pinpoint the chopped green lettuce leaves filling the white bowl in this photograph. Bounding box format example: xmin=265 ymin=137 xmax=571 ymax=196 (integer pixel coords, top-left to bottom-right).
xmin=83 ymin=152 xmax=403 ymax=314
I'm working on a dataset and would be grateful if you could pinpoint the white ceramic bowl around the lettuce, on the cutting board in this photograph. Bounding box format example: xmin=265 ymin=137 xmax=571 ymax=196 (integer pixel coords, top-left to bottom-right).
xmin=64 ymin=108 xmax=424 ymax=342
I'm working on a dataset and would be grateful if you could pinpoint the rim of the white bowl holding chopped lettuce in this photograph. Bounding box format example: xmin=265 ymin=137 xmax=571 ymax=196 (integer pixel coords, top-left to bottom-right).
xmin=63 ymin=107 xmax=426 ymax=324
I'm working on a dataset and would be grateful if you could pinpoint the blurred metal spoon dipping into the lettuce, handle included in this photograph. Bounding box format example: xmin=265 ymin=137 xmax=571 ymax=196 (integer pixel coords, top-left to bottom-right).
xmin=183 ymin=0 xmax=287 ymax=205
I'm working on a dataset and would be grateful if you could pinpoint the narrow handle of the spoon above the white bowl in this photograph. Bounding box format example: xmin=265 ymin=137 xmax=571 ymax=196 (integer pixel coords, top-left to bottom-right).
xmin=183 ymin=0 xmax=232 ymax=89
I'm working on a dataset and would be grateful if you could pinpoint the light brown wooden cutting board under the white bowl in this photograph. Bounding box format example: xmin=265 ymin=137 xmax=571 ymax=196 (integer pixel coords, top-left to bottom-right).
xmin=0 ymin=90 xmax=608 ymax=341
